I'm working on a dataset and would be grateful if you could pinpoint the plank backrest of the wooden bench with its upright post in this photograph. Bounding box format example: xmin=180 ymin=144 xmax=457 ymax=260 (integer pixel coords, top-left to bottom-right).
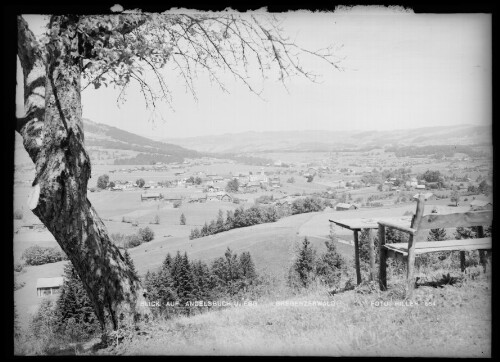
xmin=412 ymin=195 xmax=493 ymax=235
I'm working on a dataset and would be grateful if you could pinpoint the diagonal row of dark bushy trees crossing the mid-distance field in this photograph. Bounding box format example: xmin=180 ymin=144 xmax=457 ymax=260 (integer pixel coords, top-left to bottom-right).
xmin=189 ymin=196 xmax=332 ymax=240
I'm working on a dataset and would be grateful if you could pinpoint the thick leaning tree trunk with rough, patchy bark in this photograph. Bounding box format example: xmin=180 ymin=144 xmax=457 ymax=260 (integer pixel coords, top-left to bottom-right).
xmin=18 ymin=16 xmax=149 ymax=332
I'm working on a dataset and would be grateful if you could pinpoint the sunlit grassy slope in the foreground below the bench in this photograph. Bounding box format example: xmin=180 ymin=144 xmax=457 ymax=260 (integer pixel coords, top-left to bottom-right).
xmin=93 ymin=270 xmax=491 ymax=357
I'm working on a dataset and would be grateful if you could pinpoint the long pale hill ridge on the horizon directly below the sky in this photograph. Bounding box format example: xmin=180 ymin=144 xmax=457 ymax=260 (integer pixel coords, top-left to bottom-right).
xmin=164 ymin=125 xmax=491 ymax=152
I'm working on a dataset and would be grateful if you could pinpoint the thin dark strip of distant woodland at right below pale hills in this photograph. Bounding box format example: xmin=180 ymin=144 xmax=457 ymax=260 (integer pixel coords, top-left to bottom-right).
xmin=385 ymin=145 xmax=486 ymax=158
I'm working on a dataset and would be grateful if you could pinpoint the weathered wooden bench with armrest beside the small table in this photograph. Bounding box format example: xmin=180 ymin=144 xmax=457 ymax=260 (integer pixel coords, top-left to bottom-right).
xmin=378 ymin=195 xmax=493 ymax=297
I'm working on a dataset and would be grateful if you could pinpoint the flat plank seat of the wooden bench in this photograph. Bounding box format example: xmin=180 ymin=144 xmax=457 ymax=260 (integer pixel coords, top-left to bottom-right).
xmin=383 ymin=238 xmax=491 ymax=256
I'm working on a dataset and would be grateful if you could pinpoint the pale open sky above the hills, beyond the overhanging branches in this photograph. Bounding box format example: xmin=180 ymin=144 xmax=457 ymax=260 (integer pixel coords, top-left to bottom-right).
xmin=18 ymin=8 xmax=492 ymax=139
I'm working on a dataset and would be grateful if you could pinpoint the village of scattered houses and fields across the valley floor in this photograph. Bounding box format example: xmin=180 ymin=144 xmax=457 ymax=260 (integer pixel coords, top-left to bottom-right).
xmin=80 ymin=148 xmax=492 ymax=214
